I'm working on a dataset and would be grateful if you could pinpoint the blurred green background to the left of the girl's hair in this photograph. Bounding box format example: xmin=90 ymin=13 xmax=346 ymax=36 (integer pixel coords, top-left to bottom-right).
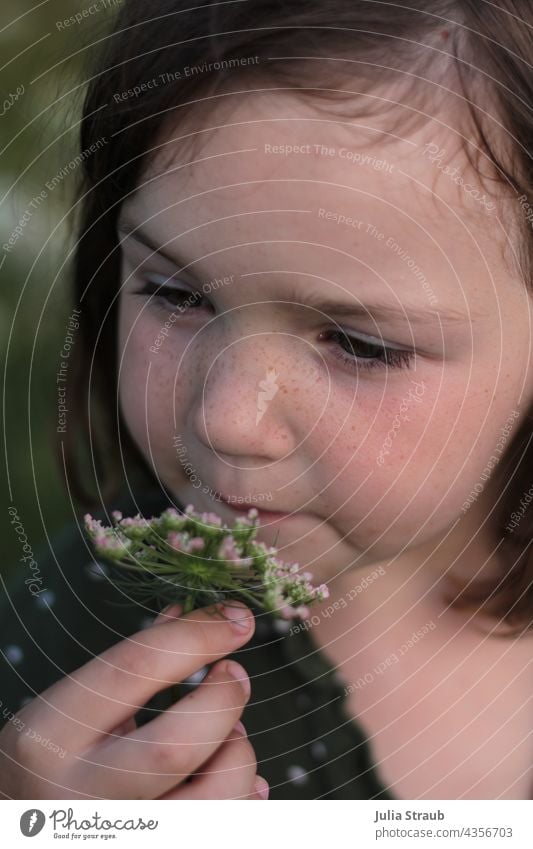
xmin=0 ymin=0 xmax=119 ymax=575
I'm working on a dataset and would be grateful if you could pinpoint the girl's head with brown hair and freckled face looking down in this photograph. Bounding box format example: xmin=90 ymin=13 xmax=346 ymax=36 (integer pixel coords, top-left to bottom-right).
xmin=68 ymin=0 xmax=533 ymax=621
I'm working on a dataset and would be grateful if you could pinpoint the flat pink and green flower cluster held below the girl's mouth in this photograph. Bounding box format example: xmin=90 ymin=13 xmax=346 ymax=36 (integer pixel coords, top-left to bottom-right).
xmin=84 ymin=504 xmax=329 ymax=619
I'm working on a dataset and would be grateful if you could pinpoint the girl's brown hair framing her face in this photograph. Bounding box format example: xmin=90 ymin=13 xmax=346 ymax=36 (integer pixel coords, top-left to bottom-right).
xmin=66 ymin=0 xmax=533 ymax=627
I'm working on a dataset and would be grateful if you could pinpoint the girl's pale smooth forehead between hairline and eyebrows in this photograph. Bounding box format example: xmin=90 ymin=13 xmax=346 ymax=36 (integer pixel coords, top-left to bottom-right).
xmin=123 ymin=91 xmax=508 ymax=307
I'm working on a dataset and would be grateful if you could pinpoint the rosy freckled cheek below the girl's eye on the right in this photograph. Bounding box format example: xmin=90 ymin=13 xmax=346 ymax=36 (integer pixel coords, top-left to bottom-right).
xmin=323 ymin=385 xmax=506 ymax=541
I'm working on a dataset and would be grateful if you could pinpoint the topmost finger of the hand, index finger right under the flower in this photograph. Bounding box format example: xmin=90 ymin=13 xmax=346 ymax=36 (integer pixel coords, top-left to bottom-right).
xmin=34 ymin=602 xmax=255 ymax=752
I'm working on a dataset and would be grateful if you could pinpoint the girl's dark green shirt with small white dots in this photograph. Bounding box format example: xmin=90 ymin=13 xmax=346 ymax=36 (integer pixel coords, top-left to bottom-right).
xmin=0 ymin=492 xmax=395 ymax=800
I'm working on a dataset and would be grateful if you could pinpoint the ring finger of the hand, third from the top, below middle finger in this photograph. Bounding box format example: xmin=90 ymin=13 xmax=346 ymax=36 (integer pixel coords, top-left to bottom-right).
xmin=159 ymin=730 xmax=257 ymax=799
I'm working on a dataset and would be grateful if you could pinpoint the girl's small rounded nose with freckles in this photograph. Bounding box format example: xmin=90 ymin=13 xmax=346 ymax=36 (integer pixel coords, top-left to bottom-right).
xmin=189 ymin=335 xmax=293 ymax=463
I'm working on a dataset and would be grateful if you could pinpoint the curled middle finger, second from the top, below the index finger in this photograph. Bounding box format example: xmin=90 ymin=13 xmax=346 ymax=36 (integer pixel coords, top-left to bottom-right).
xmin=68 ymin=660 xmax=250 ymax=799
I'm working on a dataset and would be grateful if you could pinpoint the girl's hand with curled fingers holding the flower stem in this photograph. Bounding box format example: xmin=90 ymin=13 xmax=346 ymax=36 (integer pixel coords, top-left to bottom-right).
xmin=0 ymin=600 xmax=266 ymax=799
